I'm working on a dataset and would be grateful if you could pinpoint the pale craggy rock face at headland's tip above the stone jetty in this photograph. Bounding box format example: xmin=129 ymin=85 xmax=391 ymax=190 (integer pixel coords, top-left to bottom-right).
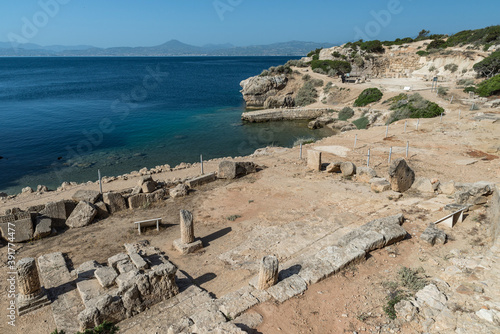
xmin=240 ymin=74 xmax=288 ymax=108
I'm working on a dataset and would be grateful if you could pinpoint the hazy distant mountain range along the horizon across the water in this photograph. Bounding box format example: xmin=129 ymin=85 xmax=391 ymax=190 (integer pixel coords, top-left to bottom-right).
xmin=0 ymin=40 xmax=334 ymax=57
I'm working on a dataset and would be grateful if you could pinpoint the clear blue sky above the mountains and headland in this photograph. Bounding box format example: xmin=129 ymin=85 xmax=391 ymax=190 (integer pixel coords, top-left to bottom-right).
xmin=0 ymin=0 xmax=500 ymax=47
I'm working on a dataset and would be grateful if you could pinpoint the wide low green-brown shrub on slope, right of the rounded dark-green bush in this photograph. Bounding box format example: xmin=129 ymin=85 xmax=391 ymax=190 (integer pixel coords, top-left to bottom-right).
xmin=387 ymin=93 xmax=444 ymax=124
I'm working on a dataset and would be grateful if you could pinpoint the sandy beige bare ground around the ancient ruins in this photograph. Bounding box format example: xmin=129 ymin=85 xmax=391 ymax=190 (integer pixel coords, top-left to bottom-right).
xmin=0 ymin=76 xmax=500 ymax=334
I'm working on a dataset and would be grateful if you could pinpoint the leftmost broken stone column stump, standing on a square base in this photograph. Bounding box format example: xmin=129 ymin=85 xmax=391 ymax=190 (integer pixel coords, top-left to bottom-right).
xmin=17 ymin=257 xmax=50 ymax=315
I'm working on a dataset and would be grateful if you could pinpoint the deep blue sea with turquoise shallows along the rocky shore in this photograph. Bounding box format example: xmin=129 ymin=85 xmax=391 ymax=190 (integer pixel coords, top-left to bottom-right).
xmin=0 ymin=57 xmax=331 ymax=193
